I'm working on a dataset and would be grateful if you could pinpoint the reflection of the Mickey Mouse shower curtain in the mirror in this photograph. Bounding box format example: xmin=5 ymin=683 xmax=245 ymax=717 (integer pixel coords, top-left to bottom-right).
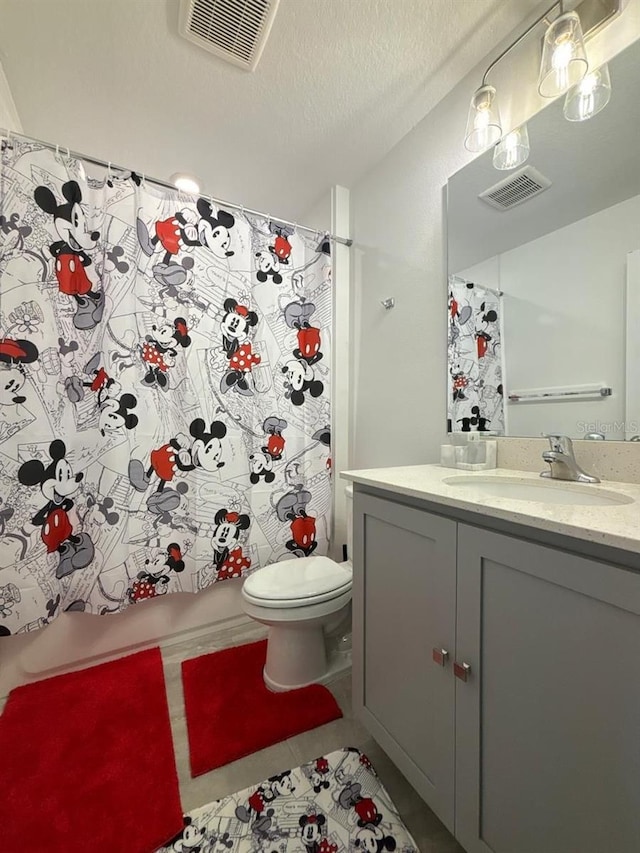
xmin=447 ymin=276 xmax=504 ymax=435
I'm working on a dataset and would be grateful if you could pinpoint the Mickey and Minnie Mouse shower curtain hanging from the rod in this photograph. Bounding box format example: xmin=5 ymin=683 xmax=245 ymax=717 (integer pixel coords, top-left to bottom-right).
xmin=0 ymin=140 xmax=332 ymax=634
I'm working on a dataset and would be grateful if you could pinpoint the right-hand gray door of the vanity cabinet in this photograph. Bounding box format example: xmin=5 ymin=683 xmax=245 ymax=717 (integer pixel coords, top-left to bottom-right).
xmin=455 ymin=524 xmax=640 ymax=853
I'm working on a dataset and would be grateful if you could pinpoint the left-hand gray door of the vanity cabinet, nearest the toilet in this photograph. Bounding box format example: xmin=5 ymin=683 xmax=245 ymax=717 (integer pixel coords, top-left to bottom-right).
xmin=353 ymin=490 xmax=456 ymax=830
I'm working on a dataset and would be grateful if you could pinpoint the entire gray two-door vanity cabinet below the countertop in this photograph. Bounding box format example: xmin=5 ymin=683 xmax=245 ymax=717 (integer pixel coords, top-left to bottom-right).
xmin=353 ymin=490 xmax=640 ymax=853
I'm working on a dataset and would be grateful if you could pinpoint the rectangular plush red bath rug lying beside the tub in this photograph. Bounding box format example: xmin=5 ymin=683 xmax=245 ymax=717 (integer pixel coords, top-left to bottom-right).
xmin=0 ymin=649 xmax=183 ymax=853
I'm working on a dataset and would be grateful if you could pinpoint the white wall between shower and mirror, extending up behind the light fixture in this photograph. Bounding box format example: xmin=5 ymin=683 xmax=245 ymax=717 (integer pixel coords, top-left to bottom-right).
xmin=351 ymin=0 xmax=640 ymax=468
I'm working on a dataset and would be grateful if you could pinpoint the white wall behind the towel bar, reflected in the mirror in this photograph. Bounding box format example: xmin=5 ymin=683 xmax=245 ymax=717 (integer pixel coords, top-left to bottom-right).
xmin=460 ymin=196 xmax=640 ymax=439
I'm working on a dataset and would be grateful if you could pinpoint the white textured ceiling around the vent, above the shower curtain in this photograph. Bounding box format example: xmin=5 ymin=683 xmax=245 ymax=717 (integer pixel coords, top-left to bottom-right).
xmin=0 ymin=0 xmax=538 ymax=220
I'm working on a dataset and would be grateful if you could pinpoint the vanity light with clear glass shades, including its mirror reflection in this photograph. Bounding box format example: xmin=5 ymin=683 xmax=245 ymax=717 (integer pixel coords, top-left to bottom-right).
xmin=464 ymin=0 xmax=622 ymax=151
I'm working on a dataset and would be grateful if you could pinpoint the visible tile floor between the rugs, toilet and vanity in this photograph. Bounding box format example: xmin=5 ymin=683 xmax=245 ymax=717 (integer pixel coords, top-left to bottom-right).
xmin=158 ymin=622 xmax=464 ymax=853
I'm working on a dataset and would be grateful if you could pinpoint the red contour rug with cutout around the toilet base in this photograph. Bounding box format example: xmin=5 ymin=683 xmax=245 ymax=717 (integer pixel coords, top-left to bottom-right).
xmin=182 ymin=640 xmax=342 ymax=776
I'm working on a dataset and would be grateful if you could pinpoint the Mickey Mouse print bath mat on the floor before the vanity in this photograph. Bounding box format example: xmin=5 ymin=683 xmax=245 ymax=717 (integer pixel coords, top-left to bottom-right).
xmin=158 ymin=747 xmax=418 ymax=853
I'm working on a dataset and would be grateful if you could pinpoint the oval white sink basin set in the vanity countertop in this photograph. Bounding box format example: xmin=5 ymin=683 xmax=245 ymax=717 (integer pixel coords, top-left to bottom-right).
xmin=443 ymin=476 xmax=633 ymax=506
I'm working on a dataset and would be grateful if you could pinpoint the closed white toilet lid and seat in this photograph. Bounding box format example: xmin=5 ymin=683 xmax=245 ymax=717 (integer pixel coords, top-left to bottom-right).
xmin=242 ymin=557 xmax=353 ymax=608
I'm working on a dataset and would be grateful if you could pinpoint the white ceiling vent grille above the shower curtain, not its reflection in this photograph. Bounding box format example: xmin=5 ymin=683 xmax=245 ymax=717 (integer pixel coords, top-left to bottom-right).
xmin=180 ymin=0 xmax=280 ymax=71
